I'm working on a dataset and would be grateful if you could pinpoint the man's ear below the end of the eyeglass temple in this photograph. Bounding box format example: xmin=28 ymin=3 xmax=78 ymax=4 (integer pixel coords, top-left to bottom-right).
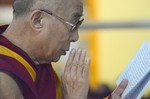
xmin=30 ymin=10 xmax=43 ymax=31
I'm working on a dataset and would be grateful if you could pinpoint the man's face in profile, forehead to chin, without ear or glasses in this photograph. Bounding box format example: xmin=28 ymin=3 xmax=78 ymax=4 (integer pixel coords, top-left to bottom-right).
xmin=39 ymin=0 xmax=83 ymax=62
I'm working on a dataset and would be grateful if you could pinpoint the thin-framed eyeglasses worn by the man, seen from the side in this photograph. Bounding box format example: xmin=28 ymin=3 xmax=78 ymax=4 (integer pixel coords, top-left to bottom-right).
xmin=40 ymin=9 xmax=84 ymax=32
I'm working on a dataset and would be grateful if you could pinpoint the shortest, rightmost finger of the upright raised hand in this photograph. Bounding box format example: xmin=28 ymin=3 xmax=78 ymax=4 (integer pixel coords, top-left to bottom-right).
xmin=83 ymin=58 xmax=91 ymax=79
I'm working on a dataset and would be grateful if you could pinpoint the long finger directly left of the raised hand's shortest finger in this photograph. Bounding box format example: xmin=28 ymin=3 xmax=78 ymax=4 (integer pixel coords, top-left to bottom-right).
xmin=77 ymin=50 xmax=86 ymax=76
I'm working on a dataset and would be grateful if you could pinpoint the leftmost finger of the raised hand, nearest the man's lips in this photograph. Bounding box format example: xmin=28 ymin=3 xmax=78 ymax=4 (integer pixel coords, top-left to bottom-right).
xmin=64 ymin=49 xmax=76 ymax=73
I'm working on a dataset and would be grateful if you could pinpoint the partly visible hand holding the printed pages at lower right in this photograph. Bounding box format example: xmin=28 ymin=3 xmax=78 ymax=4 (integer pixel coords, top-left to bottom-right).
xmin=108 ymin=79 xmax=128 ymax=99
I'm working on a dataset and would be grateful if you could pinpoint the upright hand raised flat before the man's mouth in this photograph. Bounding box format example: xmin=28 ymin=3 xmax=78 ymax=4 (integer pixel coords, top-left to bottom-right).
xmin=62 ymin=48 xmax=90 ymax=99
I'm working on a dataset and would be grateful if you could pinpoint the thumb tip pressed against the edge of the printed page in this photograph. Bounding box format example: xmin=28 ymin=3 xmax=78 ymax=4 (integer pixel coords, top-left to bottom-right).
xmin=113 ymin=79 xmax=128 ymax=96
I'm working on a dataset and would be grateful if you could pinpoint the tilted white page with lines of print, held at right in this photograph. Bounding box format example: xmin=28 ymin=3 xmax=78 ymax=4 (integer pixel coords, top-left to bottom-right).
xmin=117 ymin=41 xmax=150 ymax=99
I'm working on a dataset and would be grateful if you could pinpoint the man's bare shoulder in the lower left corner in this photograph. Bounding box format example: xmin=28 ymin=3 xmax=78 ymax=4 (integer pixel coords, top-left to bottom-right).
xmin=0 ymin=72 xmax=24 ymax=99
